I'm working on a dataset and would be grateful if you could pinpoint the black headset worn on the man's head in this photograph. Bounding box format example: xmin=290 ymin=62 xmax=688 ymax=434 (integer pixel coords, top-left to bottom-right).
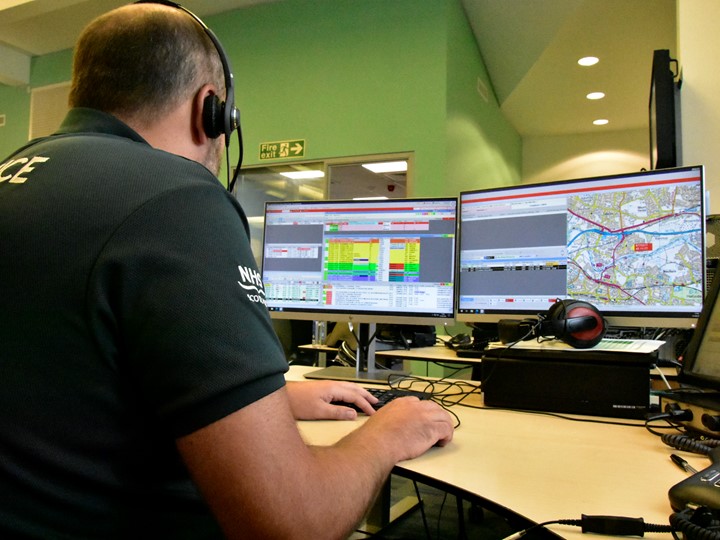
xmin=134 ymin=0 xmax=243 ymax=192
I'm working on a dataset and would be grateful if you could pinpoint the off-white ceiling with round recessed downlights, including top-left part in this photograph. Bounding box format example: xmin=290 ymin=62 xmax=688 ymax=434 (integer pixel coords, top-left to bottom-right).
xmin=0 ymin=0 xmax=677 ymax=136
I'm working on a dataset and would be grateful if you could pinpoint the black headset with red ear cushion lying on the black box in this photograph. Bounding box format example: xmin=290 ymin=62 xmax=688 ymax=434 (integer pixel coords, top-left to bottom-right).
xmin=498 ymin=300 xmax=607 ymax=349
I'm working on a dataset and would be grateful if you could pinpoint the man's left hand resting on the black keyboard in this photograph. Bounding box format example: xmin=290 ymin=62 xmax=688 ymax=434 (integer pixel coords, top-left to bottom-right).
xmin=287 ymin=381 xmax=377 ymax=420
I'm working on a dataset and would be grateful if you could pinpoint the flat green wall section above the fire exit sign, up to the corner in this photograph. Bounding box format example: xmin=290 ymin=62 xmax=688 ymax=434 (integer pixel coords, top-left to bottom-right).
xmin=209 ymin=0 xmax=446 ymax=195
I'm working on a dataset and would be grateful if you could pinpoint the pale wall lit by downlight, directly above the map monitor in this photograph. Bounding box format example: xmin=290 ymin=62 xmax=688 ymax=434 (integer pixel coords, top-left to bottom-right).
xmin=522 ymin=130 xmax=650 ymax=184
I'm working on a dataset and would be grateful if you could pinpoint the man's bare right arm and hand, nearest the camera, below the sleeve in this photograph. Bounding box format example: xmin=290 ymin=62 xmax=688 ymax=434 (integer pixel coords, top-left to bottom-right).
xmin=177 ymin=388 xmax=453 ymax=539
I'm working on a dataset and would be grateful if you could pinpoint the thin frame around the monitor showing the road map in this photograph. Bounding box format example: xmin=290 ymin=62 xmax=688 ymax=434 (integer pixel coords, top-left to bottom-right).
xmin=455 ymin=165 xmax=707 ymax=329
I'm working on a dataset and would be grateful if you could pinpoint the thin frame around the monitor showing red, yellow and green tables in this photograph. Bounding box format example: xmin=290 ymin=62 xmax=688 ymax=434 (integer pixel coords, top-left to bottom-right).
xmin=260 ymin=197 xmax=459 ymax=326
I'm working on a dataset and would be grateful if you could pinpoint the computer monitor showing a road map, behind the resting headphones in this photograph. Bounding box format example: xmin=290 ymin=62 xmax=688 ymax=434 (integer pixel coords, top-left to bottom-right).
xmin=457 ymin=166 xmax=705 ymax=328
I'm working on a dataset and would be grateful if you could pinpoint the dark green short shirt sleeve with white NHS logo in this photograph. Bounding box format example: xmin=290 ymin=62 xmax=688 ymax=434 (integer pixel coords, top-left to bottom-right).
xmin=88 ymin=184 xmax=287 ymax=437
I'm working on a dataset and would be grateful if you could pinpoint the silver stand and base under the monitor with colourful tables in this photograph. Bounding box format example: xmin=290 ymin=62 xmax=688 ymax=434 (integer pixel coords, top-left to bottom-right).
xmin=305 ymin=323 xmax=408 ymax=384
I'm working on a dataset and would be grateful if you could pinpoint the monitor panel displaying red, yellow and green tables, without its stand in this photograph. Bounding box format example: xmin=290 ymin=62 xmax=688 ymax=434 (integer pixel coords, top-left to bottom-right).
xmin=262 ymin=198 xmax=457 ymax=322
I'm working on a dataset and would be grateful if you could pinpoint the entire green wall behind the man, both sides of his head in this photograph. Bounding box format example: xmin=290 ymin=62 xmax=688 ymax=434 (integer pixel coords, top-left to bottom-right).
xmin=0 ymin=0 xmax=521 ymax=196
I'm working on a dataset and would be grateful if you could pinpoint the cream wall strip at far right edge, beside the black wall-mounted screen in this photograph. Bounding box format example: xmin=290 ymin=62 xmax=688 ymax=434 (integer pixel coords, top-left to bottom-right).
xmin=677 ymin=0 xmax=720 ymax=214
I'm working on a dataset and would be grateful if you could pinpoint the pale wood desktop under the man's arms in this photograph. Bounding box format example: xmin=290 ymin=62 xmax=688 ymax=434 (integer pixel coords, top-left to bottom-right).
xmin=288 ymin=366 xmax=696 ymax=540
